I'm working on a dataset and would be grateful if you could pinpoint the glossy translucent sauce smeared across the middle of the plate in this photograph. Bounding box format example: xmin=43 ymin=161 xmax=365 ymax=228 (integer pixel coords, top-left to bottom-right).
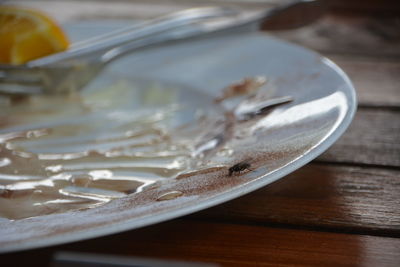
xmin=0 ymin=79 xmax=231 ymax=219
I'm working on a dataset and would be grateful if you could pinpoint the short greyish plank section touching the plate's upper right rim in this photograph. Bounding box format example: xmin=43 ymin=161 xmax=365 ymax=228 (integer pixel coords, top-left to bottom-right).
xmin=329 ymin=55 xmax=400 ymax=107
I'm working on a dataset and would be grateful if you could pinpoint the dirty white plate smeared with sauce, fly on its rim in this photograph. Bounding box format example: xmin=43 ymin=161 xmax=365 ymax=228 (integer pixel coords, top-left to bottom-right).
xmin=0 ymin=22 xmax=356 ymax=252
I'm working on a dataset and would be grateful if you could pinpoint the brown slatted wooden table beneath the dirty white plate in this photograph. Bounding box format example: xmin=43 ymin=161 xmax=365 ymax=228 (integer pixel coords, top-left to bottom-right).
xmin=0 ymin=1 xmax=400 ymax=266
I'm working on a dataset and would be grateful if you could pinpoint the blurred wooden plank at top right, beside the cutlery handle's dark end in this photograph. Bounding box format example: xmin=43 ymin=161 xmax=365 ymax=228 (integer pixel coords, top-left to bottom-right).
xmin=273 ymin=14 xmax=400 ymax=58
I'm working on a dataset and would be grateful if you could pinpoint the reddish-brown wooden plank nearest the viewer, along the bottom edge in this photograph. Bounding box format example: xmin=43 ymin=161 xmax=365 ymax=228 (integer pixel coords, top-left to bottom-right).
xmin=1 ymin=220 xmax=400 ymax=266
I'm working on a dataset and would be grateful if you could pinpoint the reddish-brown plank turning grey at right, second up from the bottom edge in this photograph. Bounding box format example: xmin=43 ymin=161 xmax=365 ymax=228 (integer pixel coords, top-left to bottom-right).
xmin=192 ymin=164 xmax=400 ymax=236
